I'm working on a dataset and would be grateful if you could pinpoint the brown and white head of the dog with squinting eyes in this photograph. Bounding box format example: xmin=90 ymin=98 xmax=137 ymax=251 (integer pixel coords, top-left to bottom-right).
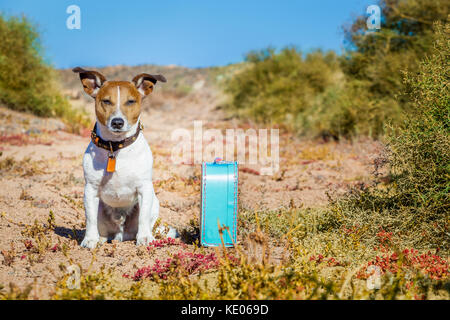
xmin=72 ymin=67 xmax=166 ymax=134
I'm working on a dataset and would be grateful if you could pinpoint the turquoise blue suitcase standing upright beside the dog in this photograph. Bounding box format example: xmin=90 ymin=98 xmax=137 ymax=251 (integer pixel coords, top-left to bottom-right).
xmin=200 ymin=159 xmax=238 ymax=247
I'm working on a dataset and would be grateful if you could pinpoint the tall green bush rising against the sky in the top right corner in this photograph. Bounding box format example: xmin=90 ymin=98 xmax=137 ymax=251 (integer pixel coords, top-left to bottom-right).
xmin=328 ymin=0 xmax=450 ymax=137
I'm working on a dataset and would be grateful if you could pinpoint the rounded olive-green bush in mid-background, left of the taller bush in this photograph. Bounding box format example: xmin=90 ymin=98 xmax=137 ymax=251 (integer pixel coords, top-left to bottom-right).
xmin=225 ymin=48 xmax=338 ymax=126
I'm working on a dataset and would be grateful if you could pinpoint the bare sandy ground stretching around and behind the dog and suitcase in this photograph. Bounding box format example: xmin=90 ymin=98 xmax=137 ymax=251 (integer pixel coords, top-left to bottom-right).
xmin=0 ymin=81 xmax=382 ymax=299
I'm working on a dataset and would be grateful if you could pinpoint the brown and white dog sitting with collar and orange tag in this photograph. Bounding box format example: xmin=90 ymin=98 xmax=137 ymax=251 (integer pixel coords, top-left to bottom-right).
xmin=72 ymin=67 xmax=176 ymax=249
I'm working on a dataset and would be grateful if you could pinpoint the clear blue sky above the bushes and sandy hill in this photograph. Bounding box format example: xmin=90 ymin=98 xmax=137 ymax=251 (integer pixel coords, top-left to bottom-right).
xmin=0 ymin=0 xmax=376 ymax=68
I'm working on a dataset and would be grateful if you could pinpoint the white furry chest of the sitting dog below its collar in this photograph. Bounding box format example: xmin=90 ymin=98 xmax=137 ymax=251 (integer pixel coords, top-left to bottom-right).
xmin=83 ymin=135 xmax=153 ymax=208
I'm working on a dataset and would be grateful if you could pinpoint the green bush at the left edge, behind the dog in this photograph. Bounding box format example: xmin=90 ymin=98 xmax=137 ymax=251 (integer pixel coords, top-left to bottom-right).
xmin=0 ymin=15 xmax=69 ymax=116
